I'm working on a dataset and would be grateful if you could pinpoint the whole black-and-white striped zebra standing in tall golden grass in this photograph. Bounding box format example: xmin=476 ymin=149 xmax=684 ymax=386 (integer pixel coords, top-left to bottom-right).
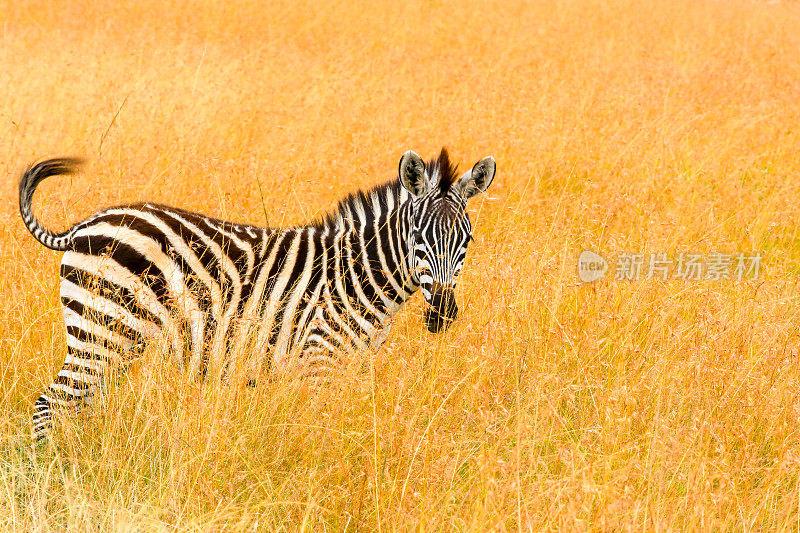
xmin=19 ymin=148 xmax=496 ymax=441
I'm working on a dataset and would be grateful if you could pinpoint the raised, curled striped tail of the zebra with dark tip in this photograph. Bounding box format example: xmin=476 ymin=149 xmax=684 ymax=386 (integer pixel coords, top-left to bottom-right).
xmin=19 ymin=158 xmax=83 ymax=251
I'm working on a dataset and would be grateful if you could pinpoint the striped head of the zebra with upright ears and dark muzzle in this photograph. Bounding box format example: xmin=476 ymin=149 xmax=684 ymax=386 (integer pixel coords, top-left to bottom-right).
xmin=400 ymin=148 xmax=496 ymax=333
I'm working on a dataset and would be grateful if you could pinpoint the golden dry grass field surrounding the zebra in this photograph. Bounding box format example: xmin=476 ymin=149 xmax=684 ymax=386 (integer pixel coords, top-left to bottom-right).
xmin=0 ymin=0 xmax=800 ymax=531
